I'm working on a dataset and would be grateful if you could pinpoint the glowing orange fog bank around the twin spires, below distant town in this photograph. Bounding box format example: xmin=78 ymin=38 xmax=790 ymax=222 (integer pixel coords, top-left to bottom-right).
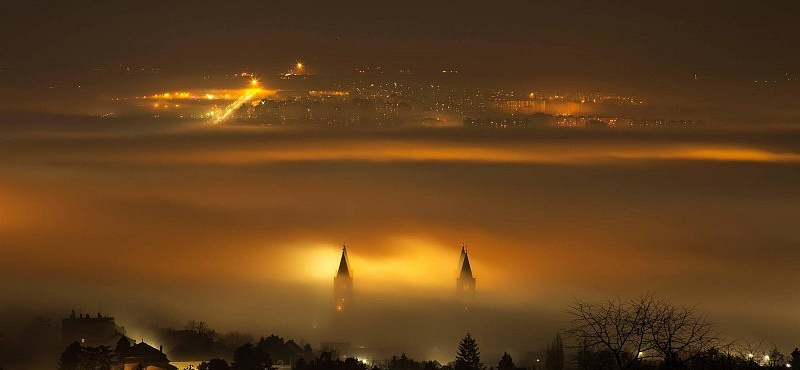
xmin=0 ymin=127 xmax=800 ymax=352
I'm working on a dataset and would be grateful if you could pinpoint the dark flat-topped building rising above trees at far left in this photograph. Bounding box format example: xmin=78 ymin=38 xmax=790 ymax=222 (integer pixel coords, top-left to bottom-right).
xmin=61 ymin=310 xmax=125 ymax=346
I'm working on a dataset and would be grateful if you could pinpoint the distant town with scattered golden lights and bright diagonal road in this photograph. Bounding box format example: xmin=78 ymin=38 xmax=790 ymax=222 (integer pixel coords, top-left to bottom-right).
xmin=78 ymin=62 xmax=704 ymax=129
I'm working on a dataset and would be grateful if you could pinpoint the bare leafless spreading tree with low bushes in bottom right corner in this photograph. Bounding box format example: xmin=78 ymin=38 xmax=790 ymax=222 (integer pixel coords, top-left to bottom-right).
xmin=565 ymin=294 xmax=800 ymax=370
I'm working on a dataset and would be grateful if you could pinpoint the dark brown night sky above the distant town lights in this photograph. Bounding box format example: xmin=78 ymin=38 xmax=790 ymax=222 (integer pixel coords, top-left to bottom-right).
xmin=0 ymin=0 xmax=800 ymax=80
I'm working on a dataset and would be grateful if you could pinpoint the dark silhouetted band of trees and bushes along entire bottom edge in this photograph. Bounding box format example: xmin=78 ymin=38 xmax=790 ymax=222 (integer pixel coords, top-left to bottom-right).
xmin=0 ymin=294 xmax=800 ymax=370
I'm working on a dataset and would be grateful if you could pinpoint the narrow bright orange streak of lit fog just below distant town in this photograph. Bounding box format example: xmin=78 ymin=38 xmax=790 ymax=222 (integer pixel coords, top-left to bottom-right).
xmin=119 ymin=141 xmax=800 ymax=165
